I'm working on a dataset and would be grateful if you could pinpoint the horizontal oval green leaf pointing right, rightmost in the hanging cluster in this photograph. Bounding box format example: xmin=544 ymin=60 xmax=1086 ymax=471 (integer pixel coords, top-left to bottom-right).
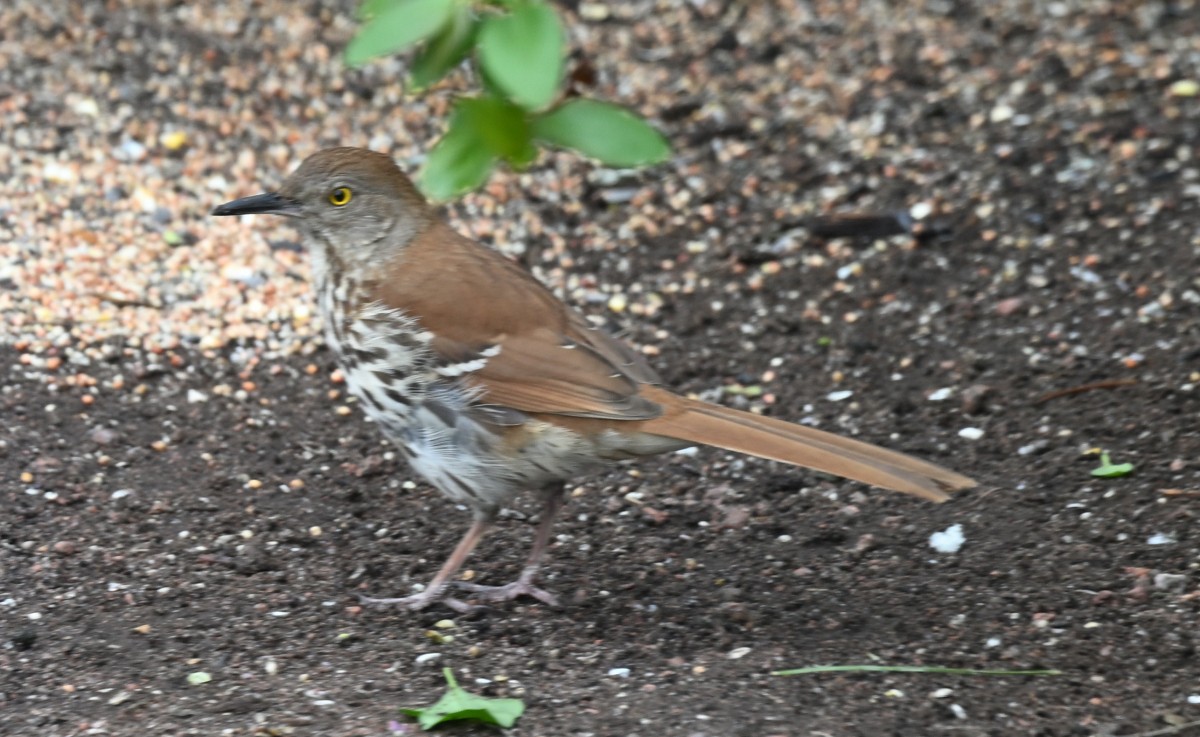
xmin=533 ymin=100 xmax=671 ymax=167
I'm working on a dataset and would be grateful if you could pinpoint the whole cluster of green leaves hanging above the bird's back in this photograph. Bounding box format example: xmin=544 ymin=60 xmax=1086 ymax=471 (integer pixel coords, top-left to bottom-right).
xmin=346 ymin=0 xmax=671 ymax=199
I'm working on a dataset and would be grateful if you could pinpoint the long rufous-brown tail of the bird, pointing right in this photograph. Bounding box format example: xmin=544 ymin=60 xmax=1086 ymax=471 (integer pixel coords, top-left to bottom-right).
xmin=644 ymin=397 xmax=976 ymax=502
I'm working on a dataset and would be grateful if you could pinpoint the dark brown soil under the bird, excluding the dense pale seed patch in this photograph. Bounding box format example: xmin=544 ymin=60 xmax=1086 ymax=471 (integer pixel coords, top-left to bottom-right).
xmin=0 ymin=2 xmax=1200 ymax=737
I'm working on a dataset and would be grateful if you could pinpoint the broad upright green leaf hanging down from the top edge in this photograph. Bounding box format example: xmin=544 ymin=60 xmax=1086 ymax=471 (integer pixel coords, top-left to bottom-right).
xmin=479 ymin=0 xmax=566 ymax=110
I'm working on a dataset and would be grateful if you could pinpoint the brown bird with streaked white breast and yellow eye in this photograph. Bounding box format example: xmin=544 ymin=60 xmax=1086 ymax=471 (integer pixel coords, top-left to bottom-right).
xmin=212 ymin=148 xmax=976 ymax=612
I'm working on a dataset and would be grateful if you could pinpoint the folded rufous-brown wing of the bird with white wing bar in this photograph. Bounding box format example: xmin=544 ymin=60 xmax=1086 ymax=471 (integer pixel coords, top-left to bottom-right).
xmin=376 ymin=224 xmax=661 ymax=421
